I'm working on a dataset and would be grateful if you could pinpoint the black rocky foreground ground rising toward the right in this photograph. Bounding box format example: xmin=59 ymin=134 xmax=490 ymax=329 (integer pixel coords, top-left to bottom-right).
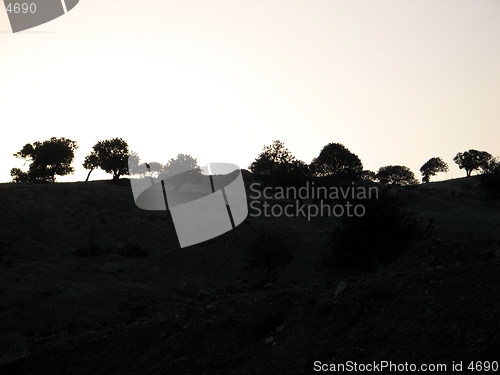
xmin=3 ymin=241 xmax=500 ymax=375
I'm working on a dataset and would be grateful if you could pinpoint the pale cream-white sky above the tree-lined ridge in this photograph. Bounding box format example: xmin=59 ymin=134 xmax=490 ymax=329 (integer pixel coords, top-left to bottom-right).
xmin=0 ymin=0 xmax=500 ymax=182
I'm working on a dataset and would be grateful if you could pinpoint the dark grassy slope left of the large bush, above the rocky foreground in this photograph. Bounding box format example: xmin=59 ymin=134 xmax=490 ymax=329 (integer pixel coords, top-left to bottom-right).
xmin=0 ymin=181 xmax=331 ymax=368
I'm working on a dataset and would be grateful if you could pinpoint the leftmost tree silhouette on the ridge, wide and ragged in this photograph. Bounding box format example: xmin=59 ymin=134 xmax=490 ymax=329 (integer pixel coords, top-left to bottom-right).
xmin=10 ymin=137 xmax=78 ymax=182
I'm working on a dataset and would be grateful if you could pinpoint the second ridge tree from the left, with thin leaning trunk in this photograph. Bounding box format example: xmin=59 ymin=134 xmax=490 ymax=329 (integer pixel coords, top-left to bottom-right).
xmin=83 ymin=138 xmax=130 ymax=181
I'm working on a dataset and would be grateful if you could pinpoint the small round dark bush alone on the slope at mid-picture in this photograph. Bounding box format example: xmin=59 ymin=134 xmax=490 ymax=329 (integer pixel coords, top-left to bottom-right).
xmin=248 ymin=231 xmax=293 ymax=273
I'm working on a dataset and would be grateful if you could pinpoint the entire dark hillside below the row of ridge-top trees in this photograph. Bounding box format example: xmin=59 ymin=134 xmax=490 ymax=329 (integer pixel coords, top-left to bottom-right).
xmin=0 ymin=178 xmax=500 ymax=374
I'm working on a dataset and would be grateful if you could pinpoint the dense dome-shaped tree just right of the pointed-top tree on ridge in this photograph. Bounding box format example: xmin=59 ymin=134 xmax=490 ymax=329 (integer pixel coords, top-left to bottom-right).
xmin=311 ymin=143 xmax=363 ymax=176
